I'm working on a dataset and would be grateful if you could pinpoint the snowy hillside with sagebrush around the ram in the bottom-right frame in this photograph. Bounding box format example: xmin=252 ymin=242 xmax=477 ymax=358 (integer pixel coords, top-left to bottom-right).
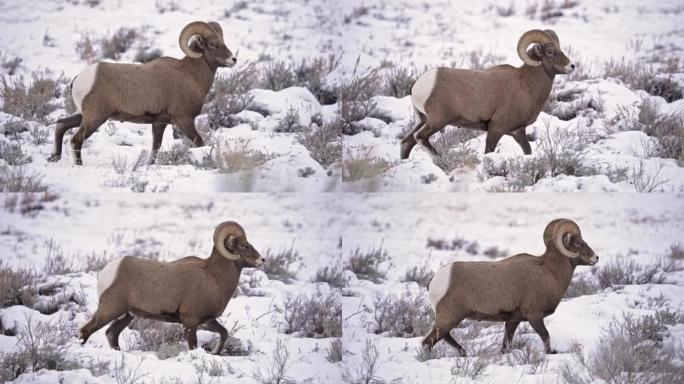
xmin=342 ymin=193 xmax=684 ymax=383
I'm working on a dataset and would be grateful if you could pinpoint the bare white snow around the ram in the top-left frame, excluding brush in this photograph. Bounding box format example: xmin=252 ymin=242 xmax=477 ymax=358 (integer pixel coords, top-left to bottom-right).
xmin=0 ymin=0 xmax=341 ymax=192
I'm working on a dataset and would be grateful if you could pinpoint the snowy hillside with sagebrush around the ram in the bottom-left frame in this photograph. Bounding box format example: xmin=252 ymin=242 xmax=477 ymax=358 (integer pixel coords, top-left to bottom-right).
xmin=0 ymin=194 xmax=341 ymax=383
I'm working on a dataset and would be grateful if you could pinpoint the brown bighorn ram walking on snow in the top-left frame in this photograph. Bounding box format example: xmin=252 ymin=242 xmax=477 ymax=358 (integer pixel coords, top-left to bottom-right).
xmin=48 ymin=21 xmax=237 ymax=165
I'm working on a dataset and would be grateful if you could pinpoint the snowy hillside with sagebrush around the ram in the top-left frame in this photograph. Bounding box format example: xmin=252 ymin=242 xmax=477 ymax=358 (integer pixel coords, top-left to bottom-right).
xmin=0 ymin=0 xmax=341 ymax=192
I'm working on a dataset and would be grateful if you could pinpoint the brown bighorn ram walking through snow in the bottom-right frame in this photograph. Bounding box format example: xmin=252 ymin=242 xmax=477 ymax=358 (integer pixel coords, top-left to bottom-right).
xmin=422 ymin=219 xmax=598 ymax=356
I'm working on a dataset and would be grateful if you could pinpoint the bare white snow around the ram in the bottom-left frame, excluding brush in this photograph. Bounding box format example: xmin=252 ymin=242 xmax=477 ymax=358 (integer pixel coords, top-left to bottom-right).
xmin=0 ymin=194 xmax=341 ymax=383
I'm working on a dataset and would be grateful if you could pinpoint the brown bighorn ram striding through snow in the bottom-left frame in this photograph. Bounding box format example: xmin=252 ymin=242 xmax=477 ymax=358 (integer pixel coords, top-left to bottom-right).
xmin=80 ymin=221 xmax=264 ymax=354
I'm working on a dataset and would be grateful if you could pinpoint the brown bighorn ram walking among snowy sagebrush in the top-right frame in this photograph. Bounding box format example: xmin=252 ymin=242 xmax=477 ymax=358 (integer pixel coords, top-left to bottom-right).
xmin=400 ymin=29 xmax=575 ymax=159
